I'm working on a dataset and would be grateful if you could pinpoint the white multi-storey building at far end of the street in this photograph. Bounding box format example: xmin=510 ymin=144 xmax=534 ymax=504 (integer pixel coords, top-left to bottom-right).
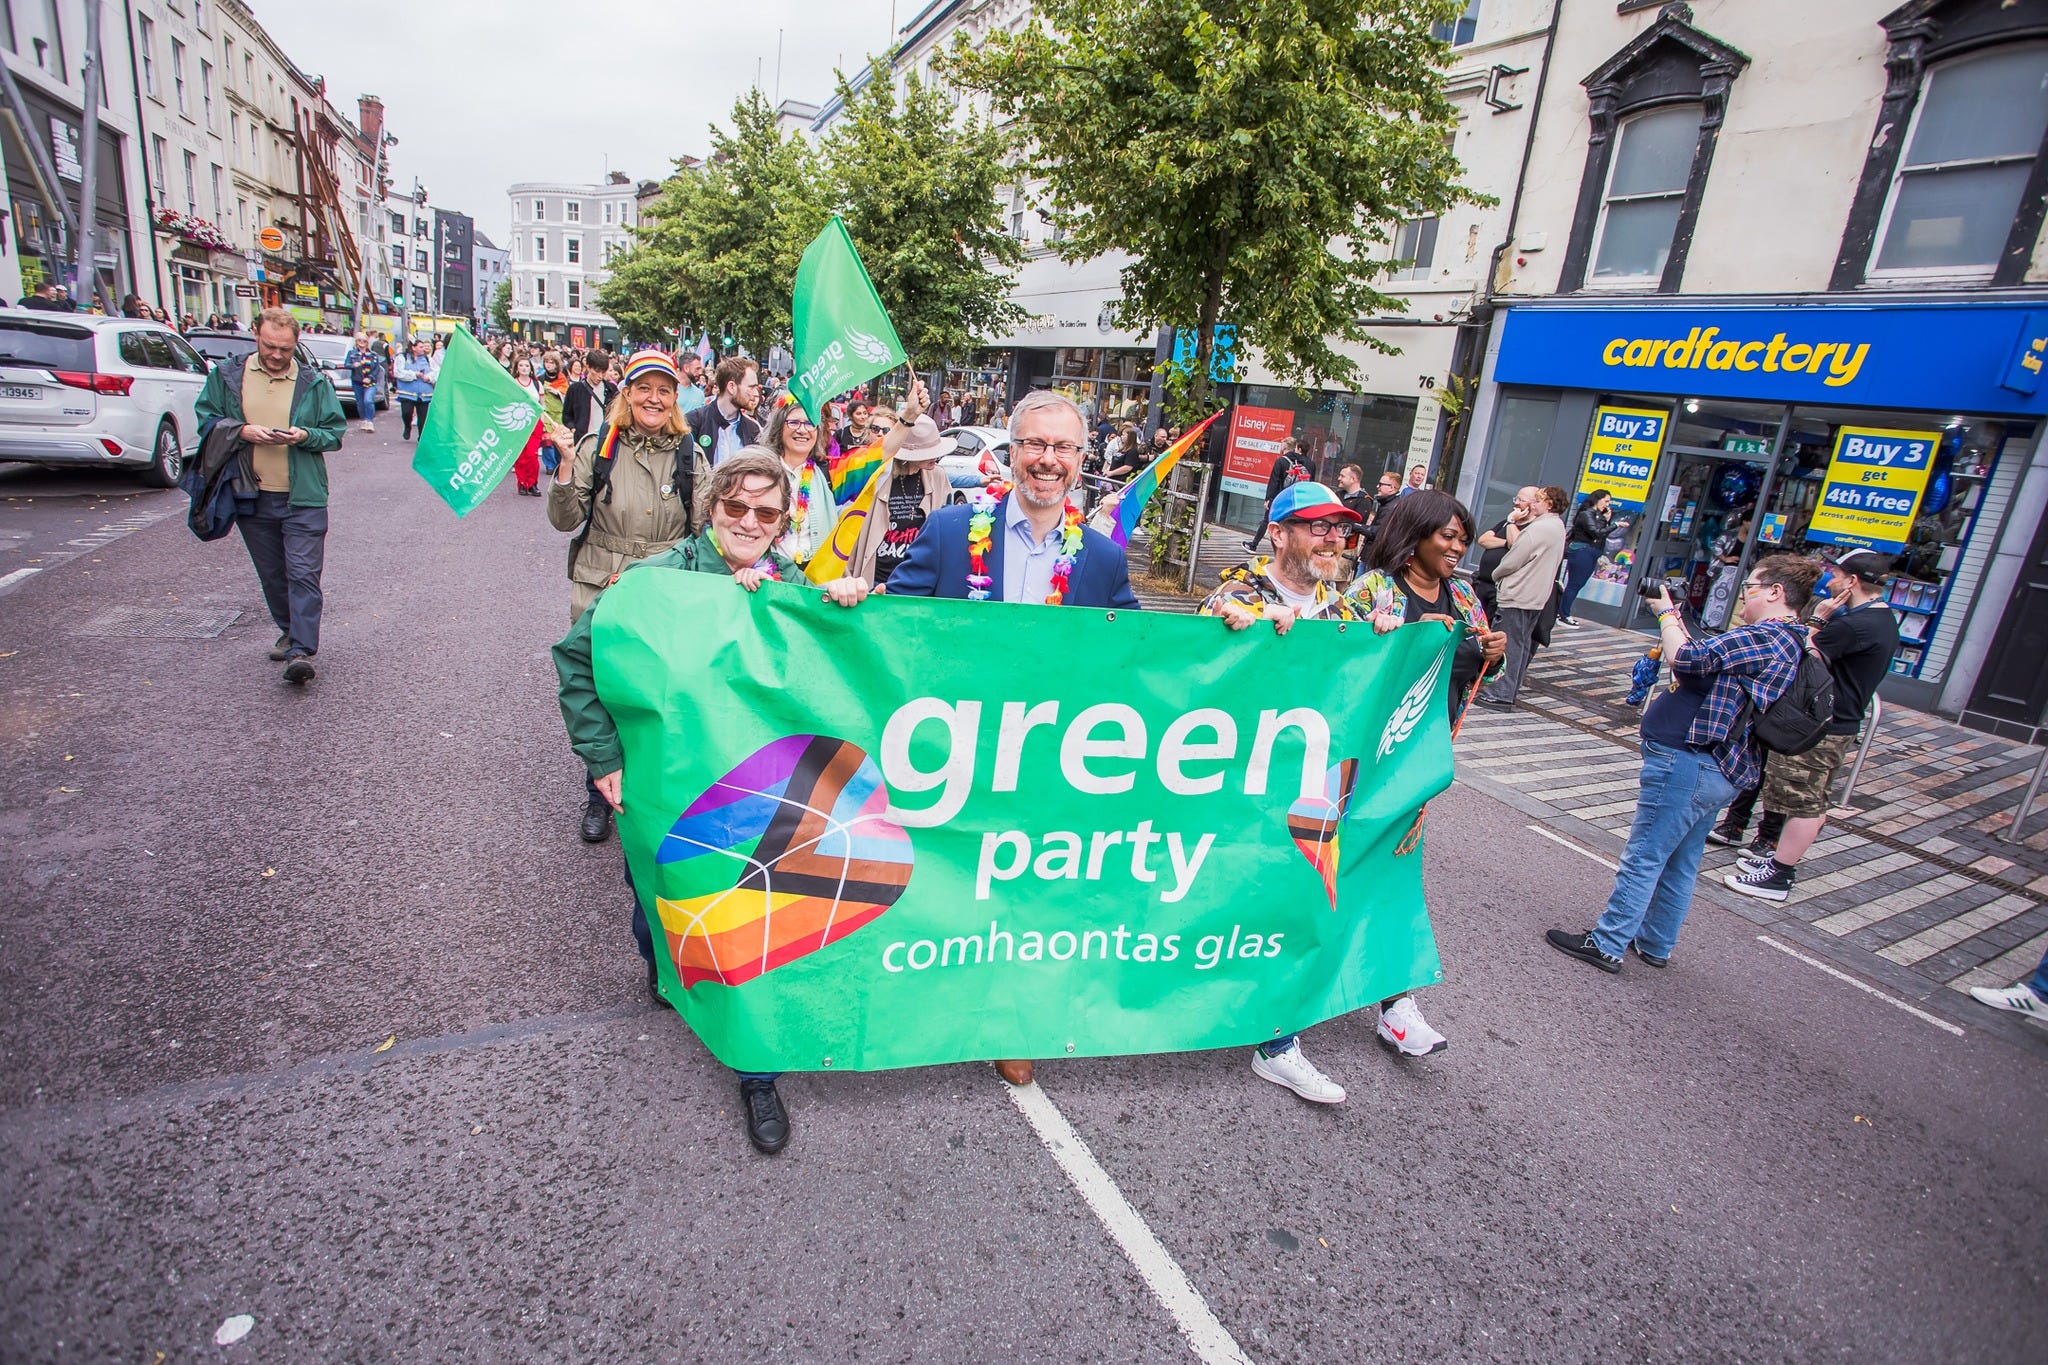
xmin=510 ymin=170 xmax=641 ymax=348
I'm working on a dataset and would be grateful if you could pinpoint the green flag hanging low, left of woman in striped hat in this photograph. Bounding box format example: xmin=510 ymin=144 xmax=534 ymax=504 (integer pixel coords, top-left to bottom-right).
xmin=412 ymin=329 xmax=541 ymax=516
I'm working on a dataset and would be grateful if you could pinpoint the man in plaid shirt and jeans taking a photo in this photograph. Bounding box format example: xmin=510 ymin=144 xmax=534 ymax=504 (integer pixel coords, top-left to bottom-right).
xmin=1544 ymin=555 xmax=1821 ymax=972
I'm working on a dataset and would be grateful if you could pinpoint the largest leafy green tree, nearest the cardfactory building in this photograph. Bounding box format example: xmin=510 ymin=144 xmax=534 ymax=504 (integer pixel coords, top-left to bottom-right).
xmin=944 ymin=0 xmax=1483 ymax=411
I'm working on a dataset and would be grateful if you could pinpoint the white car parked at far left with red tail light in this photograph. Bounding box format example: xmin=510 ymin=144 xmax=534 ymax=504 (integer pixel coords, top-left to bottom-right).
xmin=0 ymin=309 xmax=217 ymax=487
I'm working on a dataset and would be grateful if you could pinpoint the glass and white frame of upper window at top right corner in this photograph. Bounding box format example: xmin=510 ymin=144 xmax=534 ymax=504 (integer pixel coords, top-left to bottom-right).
xmin=1872 ymin=43 xmax=2048 ymax=278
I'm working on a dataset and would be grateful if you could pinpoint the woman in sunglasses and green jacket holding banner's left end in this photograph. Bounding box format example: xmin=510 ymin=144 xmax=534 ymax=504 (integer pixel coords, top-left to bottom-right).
xmin=555 ymin=446 xmax=868 ymax=1154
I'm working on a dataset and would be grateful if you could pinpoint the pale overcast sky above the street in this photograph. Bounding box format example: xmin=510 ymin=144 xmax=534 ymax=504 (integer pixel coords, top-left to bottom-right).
xmin=252 ymin=0 xmax=905 ymax=246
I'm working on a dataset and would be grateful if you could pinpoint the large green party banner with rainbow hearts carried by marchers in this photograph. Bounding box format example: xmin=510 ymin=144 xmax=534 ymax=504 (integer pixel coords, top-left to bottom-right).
xmin=592 ymin=567 xmax=1458 ymax=1070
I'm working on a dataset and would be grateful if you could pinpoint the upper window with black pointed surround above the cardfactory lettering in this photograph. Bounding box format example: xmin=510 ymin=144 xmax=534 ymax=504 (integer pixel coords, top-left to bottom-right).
xmin=1559 ymin=4 xmax=1749 ymax=295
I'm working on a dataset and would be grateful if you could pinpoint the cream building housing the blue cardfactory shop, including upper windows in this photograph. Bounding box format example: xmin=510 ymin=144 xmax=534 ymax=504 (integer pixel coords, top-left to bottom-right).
xmin=1458 ymin=0 xmax=2048 ymax=739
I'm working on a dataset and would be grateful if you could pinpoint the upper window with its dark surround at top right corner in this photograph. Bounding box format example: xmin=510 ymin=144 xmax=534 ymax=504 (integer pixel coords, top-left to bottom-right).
xmin=1829 ymin=0 xmax=2048 ymax=289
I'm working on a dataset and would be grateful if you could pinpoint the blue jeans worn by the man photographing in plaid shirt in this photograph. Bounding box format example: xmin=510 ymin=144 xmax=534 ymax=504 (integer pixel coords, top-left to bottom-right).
xmin=1593 ymin=739 xmax=1735 ymax=958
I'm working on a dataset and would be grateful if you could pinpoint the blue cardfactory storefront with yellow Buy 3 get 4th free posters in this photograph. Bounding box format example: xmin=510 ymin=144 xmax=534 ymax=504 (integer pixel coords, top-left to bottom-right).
xmin=1460 ymin=297 xmax=2048 ymax=724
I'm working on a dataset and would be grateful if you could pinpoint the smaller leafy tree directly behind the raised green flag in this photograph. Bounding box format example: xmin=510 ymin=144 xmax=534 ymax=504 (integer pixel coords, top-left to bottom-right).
xmin=823 ymin=59 xmax=1024 ymax=366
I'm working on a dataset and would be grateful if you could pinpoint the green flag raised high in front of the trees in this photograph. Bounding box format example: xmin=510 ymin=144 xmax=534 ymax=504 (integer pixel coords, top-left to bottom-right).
xmin=788 ymin=213 xmax=905 ymax=422
